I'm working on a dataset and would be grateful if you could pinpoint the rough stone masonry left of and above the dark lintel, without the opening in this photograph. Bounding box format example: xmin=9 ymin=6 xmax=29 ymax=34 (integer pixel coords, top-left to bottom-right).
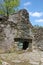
xmin=0 ymin=9 xmax=32 ymax=52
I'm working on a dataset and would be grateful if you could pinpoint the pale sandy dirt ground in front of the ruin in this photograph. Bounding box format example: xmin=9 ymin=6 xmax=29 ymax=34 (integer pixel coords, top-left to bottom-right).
xmin=0 ymin=50 xmax=43 ymax=65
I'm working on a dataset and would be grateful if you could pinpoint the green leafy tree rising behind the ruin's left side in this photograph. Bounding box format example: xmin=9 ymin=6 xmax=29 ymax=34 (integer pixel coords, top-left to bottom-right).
xmin=0 ymin=0 xmax=20 ymax=17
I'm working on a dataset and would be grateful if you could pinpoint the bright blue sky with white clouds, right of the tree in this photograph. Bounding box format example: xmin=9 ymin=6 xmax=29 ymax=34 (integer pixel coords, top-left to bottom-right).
xmin=19 ymin=0 xmax=43 ymax=26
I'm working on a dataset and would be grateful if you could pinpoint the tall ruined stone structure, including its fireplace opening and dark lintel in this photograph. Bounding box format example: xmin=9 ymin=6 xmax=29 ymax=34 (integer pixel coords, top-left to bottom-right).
xmin=0 ymin=9 xmax=33 ymax=53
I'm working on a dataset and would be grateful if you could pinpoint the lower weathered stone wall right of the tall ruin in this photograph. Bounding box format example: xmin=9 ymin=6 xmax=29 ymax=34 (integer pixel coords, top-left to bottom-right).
xmin=34 ymin=27 xmax=43 ymax=50
